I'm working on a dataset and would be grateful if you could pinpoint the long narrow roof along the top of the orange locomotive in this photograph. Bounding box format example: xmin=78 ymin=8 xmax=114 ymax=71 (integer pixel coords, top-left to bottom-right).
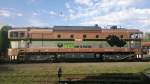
xmin=11 ymin=26 xmax=142 ymax=33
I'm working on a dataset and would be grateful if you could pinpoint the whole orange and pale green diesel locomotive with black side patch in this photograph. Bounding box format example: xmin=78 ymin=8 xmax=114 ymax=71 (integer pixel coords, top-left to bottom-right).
xmin=8 ymin=26 xmax=142 ymax=61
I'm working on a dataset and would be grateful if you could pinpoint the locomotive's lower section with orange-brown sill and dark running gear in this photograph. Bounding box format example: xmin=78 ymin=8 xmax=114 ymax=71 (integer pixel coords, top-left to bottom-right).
xmin=8 ymin=47 xmax=141 ymax=62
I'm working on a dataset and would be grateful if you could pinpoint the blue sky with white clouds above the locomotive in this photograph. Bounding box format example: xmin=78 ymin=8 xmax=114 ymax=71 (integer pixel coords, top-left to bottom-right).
xmin=0 ymin=0 xmax=150 ymax=32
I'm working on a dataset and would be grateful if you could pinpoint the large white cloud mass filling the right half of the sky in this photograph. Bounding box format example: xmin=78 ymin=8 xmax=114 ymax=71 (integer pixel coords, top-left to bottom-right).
xmin=64 ymin=0 xmax=150 ymax=31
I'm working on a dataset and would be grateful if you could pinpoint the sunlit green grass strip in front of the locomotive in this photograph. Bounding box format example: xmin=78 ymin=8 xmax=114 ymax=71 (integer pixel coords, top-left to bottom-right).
xmin=0 ymin=62 xmax=150 ymax=84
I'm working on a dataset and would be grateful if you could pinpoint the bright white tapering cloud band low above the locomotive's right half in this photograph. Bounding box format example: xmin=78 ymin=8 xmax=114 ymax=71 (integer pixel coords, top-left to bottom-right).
xmin=81 ymin=8 xmax=150 ymax=24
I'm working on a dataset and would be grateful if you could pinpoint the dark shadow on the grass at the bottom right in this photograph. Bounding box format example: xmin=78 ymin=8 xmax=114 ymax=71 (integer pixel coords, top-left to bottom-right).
xmin=59 ymin=73 xmax=150 ymax=84
